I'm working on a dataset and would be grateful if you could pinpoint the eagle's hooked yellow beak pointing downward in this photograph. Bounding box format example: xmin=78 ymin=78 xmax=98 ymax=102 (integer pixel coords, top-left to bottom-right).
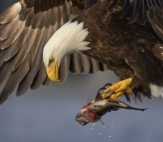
xmin=46 ymin=61 xmax=60 ymax=82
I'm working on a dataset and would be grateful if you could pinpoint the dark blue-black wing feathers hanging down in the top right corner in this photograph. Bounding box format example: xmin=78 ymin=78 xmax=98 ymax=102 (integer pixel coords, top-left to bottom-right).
xmin=109 ymin=0 xmax=163 ymax=24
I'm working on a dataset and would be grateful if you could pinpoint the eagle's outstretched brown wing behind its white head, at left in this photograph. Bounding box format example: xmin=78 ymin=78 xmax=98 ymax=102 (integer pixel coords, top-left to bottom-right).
xmin=0 ymin=0 xmax=108 ymax=104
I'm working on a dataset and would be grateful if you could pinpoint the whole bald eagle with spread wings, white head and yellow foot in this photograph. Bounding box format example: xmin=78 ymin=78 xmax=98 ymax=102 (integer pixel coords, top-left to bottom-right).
xmin=0 ymin=0 xmax=163 ymax=103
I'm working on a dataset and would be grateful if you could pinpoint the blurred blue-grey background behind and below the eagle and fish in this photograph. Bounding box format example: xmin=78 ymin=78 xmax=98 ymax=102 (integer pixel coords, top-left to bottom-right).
xmin=0 ymin=0 xmax=163 ymax=142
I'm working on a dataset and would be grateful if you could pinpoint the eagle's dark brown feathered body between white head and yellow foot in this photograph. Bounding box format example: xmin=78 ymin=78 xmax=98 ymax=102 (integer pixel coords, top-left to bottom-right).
xmin=76 ymin=0 xmax=163 ymax=98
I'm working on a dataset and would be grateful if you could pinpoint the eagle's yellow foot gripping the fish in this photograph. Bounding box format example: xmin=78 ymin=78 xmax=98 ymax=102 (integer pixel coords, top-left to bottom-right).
xmin=103 ymin=78 xmax=132 ymax=100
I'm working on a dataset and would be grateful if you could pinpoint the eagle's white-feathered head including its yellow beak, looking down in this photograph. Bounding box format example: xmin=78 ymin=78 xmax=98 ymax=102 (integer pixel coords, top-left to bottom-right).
xmin=43 ymin=22 xmax=90 ymax=81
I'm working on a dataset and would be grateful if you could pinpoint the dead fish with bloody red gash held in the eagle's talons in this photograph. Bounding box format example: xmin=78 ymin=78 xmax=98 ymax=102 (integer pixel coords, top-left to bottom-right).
xmin=75 ymin=83 xmax=146 ymax=125
